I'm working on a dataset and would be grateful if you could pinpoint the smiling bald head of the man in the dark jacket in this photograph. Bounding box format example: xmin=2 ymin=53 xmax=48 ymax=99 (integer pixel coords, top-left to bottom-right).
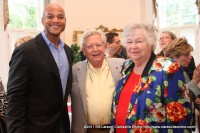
xmin=42 ymin=4 xmax=66 ymax=37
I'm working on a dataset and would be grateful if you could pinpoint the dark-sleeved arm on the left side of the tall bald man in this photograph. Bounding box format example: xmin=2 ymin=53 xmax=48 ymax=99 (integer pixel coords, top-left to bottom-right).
xmin=7 ymin=48 xmax=29 ymax=133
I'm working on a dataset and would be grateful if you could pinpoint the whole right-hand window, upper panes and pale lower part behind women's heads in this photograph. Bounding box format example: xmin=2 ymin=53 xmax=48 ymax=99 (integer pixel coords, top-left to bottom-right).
xmin=156 ymin=0 xmax=200 ymax=64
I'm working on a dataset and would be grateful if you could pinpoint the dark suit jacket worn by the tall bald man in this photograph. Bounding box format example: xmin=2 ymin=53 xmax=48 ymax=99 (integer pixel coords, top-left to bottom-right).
xmin=7 ymin=34 xmax=72 ymax=133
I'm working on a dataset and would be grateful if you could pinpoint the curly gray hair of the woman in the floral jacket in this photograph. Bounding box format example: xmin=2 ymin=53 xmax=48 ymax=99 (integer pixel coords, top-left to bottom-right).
xmin=123 ymin=22 xmax=157 ymax=51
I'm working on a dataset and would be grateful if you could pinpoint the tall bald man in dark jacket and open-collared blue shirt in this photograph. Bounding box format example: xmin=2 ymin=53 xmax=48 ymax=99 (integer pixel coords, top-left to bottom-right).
xmin=7 ymin=3 xmax=72 ymax=133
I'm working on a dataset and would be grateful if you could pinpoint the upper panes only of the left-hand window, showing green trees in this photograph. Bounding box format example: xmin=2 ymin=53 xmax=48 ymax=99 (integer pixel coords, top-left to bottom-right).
xmin=8 ymin=0 xmax=44 ymax=29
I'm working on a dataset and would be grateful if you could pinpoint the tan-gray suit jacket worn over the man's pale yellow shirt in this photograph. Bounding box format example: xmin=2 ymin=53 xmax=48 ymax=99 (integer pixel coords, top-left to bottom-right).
xmin=71 ymin=58 xmax=124 ymax=133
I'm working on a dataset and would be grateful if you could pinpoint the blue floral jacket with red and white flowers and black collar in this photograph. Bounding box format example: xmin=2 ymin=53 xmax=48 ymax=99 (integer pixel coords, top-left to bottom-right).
xmin=111 ymin=53 xmax=192 ymax=133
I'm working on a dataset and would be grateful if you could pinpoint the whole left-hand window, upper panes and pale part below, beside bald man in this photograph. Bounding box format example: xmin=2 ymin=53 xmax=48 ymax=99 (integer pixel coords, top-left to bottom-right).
xmin=7 ymin=0 xmax=50 ymax=56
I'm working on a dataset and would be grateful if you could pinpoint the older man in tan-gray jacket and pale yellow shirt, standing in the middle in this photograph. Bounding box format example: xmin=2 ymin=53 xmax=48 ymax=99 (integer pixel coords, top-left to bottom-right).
xmin=71 ymin=30 xmax=124 ymax=133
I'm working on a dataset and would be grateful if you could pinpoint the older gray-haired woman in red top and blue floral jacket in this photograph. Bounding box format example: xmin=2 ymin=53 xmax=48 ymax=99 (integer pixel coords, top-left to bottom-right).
xmin=111 ymin=23 xmax=192 ymax=133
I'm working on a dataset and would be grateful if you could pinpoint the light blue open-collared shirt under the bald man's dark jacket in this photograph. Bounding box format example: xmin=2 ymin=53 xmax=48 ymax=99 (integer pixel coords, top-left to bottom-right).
xmin=42 ymin=31 xmax=69 ymax=97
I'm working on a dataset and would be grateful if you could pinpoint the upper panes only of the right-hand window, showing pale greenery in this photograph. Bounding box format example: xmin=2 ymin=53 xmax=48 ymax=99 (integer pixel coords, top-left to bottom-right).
xmin=157 ymin=0 xmax=198 ymax=28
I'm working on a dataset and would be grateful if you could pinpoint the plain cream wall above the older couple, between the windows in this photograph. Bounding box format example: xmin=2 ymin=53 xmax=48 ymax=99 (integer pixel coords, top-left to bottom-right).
xmin=60 ymin=0 xmax=152 ymax=45
